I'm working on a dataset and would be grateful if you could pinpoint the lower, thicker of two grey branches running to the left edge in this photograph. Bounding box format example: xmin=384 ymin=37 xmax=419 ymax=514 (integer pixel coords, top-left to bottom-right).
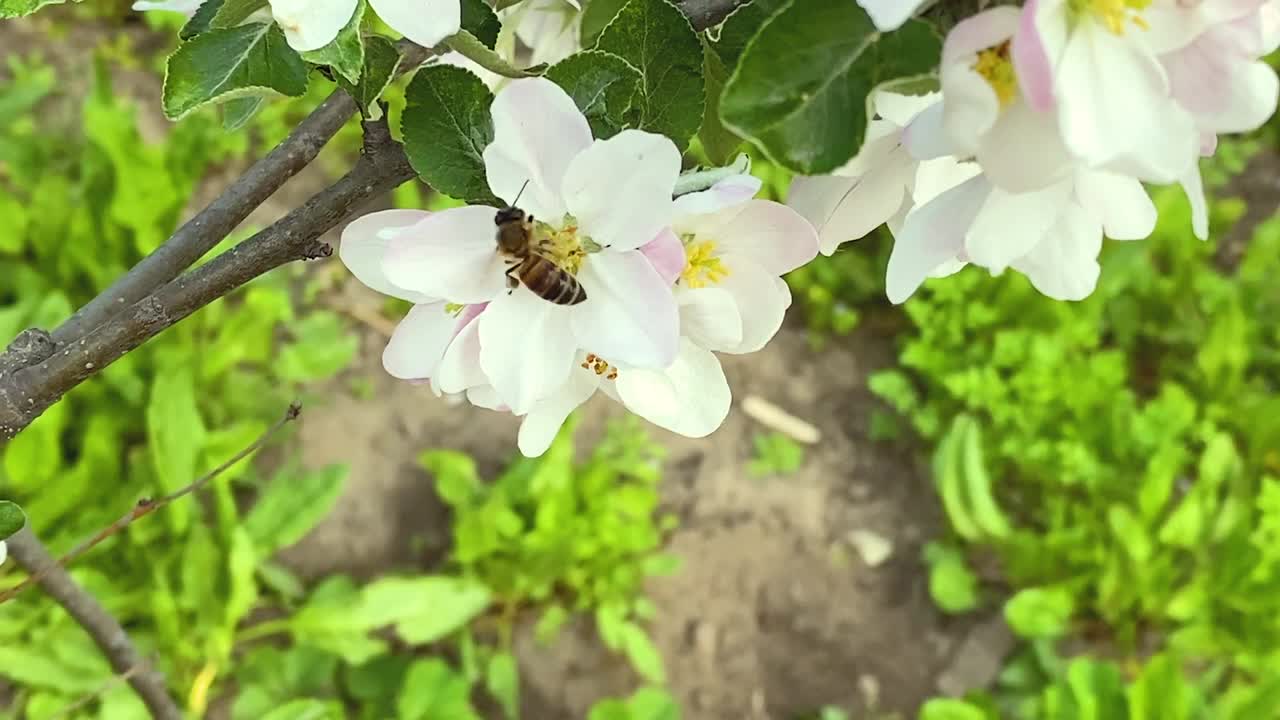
xmin=0 ymin=118 xmax=415 ymax=439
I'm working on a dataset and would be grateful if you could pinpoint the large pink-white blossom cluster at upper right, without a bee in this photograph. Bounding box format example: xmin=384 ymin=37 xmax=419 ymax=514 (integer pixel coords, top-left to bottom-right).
xmin=790 ymin=0 xmax=1280 ymax=302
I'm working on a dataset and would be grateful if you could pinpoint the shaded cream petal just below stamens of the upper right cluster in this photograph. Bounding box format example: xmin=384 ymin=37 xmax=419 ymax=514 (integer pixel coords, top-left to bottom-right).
xmin=977 ymin=102 xmax=1074 ymax=192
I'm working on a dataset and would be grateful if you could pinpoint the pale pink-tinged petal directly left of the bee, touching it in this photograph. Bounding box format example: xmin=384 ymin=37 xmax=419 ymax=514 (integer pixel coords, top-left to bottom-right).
xmin=383 ymin=205 xmax=507 ymax=302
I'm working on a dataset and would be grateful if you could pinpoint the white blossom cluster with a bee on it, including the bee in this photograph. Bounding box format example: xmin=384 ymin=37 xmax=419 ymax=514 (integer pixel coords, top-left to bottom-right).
xmin=339 ymin=78 xmax=818 ymax=455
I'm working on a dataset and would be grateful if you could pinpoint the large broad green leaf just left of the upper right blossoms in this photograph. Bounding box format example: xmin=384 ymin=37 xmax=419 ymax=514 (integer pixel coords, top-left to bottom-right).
xmin=721 ymin=0 xmax=942 ymax=174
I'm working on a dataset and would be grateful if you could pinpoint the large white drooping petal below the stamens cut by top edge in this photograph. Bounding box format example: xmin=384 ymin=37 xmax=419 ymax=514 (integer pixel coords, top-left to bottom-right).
xmin=1057 ymin=20 xmax=1198 ymax=182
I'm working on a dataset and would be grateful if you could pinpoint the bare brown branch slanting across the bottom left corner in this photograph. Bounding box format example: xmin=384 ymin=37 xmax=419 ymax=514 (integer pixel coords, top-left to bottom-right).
xmin=6 ymin=528 xmax=182 ymax=720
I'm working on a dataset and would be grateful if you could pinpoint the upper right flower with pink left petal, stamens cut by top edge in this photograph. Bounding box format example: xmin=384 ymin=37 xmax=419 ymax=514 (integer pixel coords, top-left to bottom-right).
xmin=1011 ymin=0 xmax=1198 ymax=182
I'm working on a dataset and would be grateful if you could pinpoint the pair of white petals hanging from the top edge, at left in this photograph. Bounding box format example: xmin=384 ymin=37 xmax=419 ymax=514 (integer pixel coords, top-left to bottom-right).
xmin=269 ymin=0 xmax=462 ymax=53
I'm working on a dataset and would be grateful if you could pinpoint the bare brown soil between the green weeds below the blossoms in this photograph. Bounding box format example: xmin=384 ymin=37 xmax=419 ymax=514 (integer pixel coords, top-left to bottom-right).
xmin=284 ymin=283 xmax=1005 ymax=720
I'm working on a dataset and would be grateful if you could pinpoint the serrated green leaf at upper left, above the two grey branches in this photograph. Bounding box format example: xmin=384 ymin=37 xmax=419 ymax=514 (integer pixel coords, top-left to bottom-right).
xmin=163 ymin=23 xmax=307 ymax=119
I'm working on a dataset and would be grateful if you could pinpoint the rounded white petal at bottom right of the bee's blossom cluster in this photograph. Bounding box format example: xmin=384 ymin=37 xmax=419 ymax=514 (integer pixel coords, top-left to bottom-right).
xmin=616 ymin=338 xmax=732 ymax=438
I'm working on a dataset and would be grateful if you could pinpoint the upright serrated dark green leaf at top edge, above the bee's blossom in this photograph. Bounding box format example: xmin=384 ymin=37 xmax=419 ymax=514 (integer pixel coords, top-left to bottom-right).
xmin=595 ymin=0 xmax=704 ymax=151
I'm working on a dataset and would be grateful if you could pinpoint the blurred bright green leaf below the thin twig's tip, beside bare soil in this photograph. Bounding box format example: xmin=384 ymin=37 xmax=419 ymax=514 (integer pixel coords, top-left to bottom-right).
xmin=244 ymin=465 xmax=347 ymax=557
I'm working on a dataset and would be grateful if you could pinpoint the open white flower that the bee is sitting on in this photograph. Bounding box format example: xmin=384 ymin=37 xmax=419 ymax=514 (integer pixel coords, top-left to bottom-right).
xmin=342 ymin=78 xmax=680 ymax=415
